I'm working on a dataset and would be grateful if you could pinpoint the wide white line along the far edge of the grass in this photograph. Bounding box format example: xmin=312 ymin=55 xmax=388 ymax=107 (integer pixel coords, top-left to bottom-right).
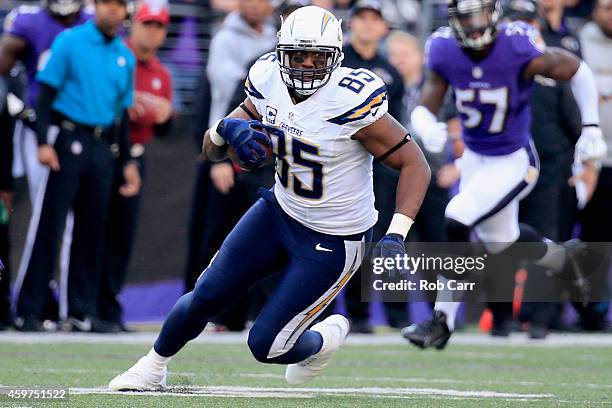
xmin=0 ymin=331 xmax=612 ymax=348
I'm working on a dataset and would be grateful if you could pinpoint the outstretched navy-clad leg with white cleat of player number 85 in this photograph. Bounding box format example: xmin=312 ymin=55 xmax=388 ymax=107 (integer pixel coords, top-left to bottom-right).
xmin=109 ymin=199 xmax=287 ymax=390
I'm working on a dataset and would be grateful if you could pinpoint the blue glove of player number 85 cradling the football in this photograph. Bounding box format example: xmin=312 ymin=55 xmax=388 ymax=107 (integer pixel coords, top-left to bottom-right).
xmin=217 ymin=118 xmax=272 ymax=167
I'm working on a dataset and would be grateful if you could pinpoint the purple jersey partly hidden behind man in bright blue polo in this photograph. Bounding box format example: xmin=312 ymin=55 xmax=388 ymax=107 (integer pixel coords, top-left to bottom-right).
xmin=4 ymin=5 xmax=93 ymax=106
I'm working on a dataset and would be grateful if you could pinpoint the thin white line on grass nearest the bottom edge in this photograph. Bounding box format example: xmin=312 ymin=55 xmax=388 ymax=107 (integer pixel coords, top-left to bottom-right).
xmin=70 ymin=385 xmax=554 ymax=400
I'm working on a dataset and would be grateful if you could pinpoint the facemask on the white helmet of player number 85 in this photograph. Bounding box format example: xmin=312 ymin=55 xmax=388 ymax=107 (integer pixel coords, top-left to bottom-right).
xmin=276 ymin=44 xmax=343 ymax=96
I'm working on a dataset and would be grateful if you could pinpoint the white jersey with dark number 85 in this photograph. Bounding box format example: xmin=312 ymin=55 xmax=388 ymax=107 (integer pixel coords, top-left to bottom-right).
xmin=245 ymin=53 xmax=388 ymax=235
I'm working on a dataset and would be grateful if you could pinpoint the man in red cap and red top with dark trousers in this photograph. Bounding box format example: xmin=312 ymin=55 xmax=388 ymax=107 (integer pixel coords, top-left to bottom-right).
xmin=98 ymin=3 xmax=172 ymax=332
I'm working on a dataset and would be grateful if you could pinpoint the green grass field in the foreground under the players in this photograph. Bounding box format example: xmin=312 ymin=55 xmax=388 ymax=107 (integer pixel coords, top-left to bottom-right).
xmin=0 ymin=334 xmax=612 ymax=407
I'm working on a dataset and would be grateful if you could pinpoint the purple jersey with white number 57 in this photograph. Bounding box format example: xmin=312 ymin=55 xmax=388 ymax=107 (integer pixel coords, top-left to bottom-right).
xmin=426 ymin=22 xmax=544 ymax=156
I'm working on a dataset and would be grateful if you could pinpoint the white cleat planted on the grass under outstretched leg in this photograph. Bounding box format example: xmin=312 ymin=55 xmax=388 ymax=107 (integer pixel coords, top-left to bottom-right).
xmin=108 ymin=355 xmax=168 ymax=391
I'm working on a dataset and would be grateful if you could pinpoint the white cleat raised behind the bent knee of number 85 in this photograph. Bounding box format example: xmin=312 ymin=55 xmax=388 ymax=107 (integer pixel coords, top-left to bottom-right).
xmin=285 ymin=314 xmax=349 ymax=384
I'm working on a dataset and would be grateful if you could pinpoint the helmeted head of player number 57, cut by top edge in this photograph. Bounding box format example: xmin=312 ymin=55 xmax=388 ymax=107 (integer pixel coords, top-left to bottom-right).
xmin=448 ymin=0 xmax=501 ymax=51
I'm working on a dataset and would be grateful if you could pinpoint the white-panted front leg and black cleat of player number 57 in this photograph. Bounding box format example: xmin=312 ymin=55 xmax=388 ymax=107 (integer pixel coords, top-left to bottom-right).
xmin=402 ymin=143 xmax=538 ymax=349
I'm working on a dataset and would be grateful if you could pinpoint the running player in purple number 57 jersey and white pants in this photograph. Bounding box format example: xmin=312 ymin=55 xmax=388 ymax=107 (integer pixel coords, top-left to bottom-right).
xmin=402 ymin=0 xmax=606 ymax=349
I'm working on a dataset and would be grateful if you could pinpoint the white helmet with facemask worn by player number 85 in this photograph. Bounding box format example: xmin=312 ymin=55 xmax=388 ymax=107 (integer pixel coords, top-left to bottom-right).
xmin=276 ymin=6 xmax=344 ymax=96
